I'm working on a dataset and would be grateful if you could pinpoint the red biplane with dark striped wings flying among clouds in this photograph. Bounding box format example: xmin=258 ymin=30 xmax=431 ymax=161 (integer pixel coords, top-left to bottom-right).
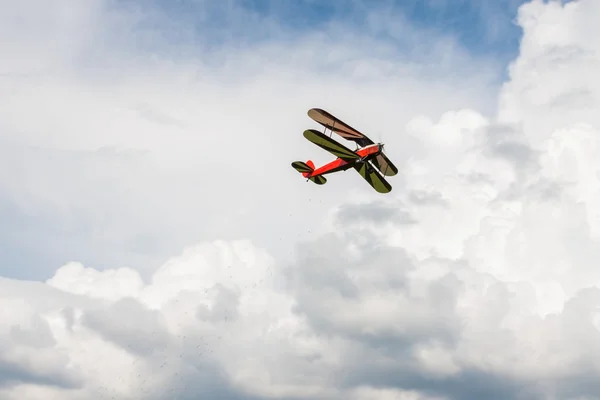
xmin=292 ymin=108 xmax=398 ymax=193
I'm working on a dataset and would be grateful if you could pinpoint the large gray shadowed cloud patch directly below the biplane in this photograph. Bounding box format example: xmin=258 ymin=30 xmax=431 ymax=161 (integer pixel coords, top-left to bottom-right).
xmin=287 ymin=234 xmax=461 ymax=347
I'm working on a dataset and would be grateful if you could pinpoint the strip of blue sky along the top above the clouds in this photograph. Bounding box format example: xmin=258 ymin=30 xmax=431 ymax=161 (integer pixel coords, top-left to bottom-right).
xmin=108 ymin=0 xmax=570 ymax=85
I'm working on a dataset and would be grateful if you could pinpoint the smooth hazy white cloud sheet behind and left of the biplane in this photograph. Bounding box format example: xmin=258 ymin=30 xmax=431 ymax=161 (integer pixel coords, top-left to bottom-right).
xmin=0 ymin=0 xmax=502 ymax=278
